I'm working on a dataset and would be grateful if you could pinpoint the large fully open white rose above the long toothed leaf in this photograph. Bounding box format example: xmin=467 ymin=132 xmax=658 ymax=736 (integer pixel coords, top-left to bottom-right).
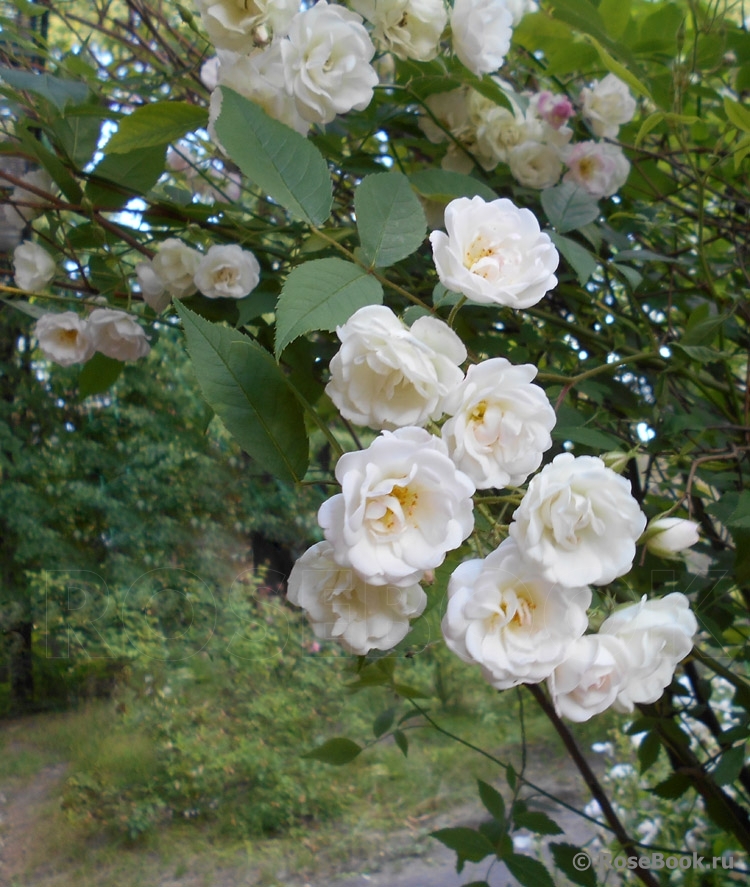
xmin=280 ymin=0 xmax=378 ymax=123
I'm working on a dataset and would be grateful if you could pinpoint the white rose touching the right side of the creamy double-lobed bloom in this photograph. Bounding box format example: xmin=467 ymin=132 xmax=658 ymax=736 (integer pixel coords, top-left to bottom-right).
xmin=442 ymin=357 xmax=555 ymax=490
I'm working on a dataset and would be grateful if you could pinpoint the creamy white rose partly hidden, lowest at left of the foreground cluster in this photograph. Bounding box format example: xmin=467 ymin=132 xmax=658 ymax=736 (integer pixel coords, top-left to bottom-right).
xmin=287 ymin=542 xmax=427 ymax=656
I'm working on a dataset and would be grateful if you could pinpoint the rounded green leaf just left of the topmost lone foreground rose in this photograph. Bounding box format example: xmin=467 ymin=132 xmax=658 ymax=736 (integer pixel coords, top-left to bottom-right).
xmin=354 ymin=172 xmax=427 ymax=268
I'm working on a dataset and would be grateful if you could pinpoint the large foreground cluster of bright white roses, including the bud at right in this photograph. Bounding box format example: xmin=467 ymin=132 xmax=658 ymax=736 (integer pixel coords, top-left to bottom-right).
xmin=288 ymin=198 xmax=697 ymax=720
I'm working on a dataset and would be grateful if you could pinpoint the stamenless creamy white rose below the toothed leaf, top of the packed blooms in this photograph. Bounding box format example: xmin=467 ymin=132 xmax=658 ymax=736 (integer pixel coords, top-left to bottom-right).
xmin=326 ymin=305 xmax=466 ymax=430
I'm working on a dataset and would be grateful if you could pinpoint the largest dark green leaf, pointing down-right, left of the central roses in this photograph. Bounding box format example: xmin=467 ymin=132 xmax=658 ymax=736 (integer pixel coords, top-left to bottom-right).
xmin=175 ymin=302 xmax=309 ymax=483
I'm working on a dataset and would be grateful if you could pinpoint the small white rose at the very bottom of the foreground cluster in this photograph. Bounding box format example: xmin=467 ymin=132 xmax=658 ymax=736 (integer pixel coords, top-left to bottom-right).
xmin=548 ymin=634 xmax=631 ymax=723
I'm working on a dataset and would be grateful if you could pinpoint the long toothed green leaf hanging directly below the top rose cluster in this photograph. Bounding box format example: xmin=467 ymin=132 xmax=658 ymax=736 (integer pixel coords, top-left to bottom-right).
xmin=216 ymin=87 xmax=333 ymax=225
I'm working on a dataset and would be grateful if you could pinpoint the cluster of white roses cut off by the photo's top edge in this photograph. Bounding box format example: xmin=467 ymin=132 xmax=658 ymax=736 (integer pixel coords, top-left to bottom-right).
xmin=197 ymin=0 xmax=535 ymax=135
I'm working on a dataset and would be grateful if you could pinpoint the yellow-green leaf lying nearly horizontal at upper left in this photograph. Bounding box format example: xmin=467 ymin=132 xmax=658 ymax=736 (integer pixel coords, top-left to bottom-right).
xmin=104 ymin=102 xmax=208 ymax=154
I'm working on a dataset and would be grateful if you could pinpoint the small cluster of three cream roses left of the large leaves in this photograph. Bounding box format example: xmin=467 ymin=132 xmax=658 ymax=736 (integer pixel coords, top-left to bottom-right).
xmin=135 ymin=237 xmax=260 ymax=314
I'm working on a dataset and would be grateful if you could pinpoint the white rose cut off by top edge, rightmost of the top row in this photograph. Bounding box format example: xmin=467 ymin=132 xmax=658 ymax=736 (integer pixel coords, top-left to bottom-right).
xmin=451 ymin=0 xmax=513 ymax=77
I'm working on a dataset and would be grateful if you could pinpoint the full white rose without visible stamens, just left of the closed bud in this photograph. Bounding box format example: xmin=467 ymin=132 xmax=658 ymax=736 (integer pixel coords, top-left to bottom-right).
xmin=509 ymin=453 xmax=646 ymax=585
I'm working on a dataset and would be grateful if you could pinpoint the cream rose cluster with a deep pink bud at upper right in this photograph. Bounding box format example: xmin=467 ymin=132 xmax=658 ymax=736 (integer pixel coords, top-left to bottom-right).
xmin=420 ymin=74 xmax=636 ymax=200
